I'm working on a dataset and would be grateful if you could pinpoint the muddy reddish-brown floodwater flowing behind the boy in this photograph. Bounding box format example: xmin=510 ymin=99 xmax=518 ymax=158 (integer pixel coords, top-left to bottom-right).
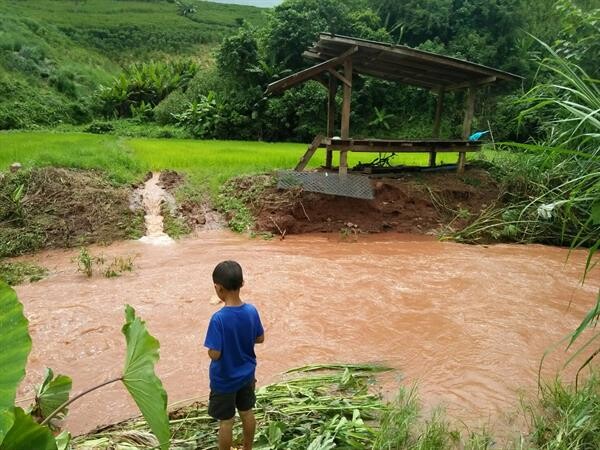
xmin=11 ymin=231 xmax=600 ymax=433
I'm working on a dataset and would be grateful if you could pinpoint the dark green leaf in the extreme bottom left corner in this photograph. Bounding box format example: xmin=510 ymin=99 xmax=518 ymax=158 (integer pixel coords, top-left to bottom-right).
xmin=0 ymin=408 xmax=58 ymax=450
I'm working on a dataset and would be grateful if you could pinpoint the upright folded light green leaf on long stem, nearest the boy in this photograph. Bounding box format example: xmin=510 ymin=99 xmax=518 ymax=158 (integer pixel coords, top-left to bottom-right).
xmin=122 ymin=305 xmax=171 ymax=450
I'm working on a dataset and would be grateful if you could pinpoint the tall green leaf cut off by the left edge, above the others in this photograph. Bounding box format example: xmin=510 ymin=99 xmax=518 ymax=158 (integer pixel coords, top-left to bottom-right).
xmin=0 ymin=281 xmax=31 ymax=443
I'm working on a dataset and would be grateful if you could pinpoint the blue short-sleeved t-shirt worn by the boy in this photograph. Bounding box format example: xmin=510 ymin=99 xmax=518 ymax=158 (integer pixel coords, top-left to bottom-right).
xmin=204 ymin=303 xmax=264 ymax=394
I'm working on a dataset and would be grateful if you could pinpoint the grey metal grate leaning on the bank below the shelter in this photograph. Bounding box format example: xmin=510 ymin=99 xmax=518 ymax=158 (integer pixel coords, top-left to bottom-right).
xmin=277 ymin=170 xmax=374 ymax=200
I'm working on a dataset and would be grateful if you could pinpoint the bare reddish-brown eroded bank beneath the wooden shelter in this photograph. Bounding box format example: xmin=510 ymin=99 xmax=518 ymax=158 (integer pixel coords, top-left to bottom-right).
xmin=225 ymin=168 xmax=500 ymax=234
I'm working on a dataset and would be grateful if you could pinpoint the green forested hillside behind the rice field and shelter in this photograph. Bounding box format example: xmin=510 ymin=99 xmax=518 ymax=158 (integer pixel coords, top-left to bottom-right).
xmin=0 ymin=0 xmax=599 ymax=141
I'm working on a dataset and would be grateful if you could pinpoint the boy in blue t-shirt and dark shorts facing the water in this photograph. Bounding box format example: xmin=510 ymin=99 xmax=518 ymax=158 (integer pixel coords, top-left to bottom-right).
xmin=204 ymin=261 xmax=265 ymax=450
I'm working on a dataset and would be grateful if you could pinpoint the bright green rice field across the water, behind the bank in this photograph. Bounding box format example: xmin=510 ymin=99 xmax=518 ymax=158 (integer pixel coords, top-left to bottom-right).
xmin=0 ymin=132 xmax=455 ymax=193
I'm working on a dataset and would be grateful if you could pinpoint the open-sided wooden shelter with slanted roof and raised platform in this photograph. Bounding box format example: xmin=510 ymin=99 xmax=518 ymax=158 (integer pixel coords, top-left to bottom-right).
xmin=267 ymin=33 xmax=521 ymax=175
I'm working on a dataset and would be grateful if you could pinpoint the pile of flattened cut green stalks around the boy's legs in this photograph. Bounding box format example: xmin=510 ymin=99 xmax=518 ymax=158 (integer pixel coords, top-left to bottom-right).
xmin=73 ymin=365 xmax=388 ymax=450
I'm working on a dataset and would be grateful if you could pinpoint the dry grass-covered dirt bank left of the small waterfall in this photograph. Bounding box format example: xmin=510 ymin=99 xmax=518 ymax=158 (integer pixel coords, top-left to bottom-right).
xmin=0 ymin=167 xmax=143 ymax=256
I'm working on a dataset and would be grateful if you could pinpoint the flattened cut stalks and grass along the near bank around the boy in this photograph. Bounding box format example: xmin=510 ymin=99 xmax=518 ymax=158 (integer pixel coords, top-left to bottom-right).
xmin=72 ymin=364 xmax=600 ymax=450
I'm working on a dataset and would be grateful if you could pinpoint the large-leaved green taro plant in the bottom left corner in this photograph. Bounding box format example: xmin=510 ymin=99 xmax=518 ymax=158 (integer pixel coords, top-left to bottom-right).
xmin=0 ymin=281 xmax=171 ymax=450
